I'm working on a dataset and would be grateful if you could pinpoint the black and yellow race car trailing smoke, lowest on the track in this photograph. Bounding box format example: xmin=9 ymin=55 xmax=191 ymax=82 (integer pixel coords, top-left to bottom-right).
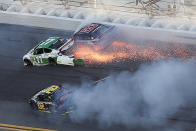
xmin=29 ymin=85 xmax=74 ymax=115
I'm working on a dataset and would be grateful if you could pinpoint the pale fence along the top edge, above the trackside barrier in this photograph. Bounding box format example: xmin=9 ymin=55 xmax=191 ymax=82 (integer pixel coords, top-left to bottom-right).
xmin=0 ymin=0 xmax=196 ymax=16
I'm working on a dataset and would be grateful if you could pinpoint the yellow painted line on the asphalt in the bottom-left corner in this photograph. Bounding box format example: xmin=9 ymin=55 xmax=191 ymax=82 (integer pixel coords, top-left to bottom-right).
xmin=0 ymin=123 xmax=56 ymax=131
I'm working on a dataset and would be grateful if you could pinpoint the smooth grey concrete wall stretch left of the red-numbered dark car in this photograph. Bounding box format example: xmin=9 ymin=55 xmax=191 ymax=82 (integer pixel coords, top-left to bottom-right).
xmin=0 ymin=12 xmax=81 ymax=31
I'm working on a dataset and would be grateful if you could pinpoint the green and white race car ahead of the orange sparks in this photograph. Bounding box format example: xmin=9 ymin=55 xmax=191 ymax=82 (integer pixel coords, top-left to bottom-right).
xmin=23 ymin=37 xmax=84 ymax=66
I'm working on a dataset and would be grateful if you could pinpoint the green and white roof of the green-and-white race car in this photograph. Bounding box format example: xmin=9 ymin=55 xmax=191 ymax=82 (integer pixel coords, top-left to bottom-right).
xmin=37 ymin=37 xmax=60 ymax=48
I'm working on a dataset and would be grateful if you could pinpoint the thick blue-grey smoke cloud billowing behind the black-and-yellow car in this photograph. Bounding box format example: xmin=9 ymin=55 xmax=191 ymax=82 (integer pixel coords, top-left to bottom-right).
xmin=60 ymin=60 xmax=196 ymax=127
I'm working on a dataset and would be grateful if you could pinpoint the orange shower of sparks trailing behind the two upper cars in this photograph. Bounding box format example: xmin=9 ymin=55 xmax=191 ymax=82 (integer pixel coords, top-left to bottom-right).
xmin=74 ymin=41 xmax=196 ymax=64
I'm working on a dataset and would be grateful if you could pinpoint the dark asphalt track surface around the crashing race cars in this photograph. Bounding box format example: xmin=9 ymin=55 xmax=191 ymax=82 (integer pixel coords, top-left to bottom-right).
xmin=0 ymin=24 xmax=196 ymax=131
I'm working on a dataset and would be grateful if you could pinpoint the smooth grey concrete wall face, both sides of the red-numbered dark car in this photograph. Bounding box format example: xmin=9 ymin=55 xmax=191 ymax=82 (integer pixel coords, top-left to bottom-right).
xmin=0 ymin=12 xmax=196 ymax=44
